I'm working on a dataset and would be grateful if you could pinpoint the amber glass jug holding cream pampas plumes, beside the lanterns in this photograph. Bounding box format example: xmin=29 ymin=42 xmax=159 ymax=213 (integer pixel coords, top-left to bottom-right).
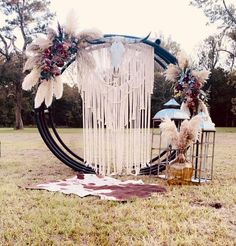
xmin=160 ymin=116 xmax=201 ymax=184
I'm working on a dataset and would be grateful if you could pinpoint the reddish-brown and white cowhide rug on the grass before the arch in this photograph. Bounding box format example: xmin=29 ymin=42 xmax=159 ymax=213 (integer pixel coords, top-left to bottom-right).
xmin=26 ymin=174 xmax=166 ymax=201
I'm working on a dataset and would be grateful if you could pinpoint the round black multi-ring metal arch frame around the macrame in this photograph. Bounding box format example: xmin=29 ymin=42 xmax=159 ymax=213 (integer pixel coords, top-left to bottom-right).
xmin=35 ymin=34 xmax=177 ymax=174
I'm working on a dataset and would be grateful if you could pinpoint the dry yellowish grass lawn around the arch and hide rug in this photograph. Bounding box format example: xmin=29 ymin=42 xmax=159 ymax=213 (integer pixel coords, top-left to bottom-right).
xmin=0 ymin=128 xmax=236 ymax=246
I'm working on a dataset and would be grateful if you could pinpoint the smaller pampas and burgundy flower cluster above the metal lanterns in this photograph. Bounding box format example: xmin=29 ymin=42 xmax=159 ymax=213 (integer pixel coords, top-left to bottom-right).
xmin=164 ymin=53 xmax=210 ymax=116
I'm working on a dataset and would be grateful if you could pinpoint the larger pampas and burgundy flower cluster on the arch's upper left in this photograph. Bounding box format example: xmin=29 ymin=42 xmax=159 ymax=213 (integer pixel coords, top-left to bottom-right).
xmin=22 ymin=13 xmax=102 ymax=108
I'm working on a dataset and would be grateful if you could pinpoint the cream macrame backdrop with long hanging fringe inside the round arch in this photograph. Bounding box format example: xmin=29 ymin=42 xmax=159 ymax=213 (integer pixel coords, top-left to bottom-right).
xmin=77 ymin=42 xmax=154 ymax=175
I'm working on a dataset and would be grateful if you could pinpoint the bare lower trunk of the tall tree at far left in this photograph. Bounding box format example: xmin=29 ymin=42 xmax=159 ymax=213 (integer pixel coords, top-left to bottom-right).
xmin=15 ymin=81 xmax=24 ymax=130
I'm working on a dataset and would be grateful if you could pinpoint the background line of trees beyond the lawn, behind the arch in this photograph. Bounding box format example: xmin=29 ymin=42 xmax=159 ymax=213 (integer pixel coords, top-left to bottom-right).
xmin=0 ymin=0 xmax=236 ymax=129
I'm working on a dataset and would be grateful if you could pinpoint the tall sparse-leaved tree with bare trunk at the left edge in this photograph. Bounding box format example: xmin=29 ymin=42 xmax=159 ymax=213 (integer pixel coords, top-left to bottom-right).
xmin=0 ymin=0 xmax=54 ymax=129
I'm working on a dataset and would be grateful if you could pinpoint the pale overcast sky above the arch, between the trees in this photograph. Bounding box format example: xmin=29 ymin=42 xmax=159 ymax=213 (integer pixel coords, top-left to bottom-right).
xmin=51 ymin=0 xmax=217 ymax=56
